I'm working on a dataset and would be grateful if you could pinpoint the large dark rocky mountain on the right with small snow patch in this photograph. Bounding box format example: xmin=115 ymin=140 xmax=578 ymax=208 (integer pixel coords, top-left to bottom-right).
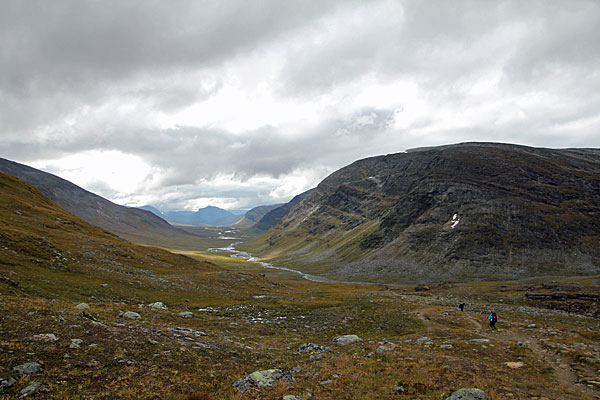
xmin=248 ymin=143 xmax=600 ymax=282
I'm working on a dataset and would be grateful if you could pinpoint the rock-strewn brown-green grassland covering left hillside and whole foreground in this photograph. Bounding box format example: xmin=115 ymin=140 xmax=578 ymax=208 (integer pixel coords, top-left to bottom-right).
xmin=0 ymin=170 xmax=600 ymax=400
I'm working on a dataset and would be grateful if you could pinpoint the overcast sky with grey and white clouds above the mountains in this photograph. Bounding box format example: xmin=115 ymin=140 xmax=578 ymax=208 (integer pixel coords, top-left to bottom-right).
xmin=0 ymin=0 xmax=600 ymax=211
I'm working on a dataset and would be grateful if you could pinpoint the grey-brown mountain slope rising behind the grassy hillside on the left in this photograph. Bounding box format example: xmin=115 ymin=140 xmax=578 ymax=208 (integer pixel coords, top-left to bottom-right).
xmin=0 ymin=158 xmax=202 ymax=246
